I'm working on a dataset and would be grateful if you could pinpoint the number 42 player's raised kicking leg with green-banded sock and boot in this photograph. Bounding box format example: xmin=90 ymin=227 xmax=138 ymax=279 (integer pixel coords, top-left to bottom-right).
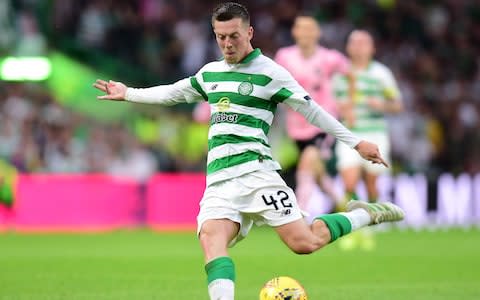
xmin=275 ymin=201 xmax=404 ymax=254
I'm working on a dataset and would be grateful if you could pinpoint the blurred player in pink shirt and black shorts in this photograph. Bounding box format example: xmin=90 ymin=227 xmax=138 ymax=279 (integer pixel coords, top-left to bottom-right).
xmin=275 ymin=15 xmax=354 ymax=210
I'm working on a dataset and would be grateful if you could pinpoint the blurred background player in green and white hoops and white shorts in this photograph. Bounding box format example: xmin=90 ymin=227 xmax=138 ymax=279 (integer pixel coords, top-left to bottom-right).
xmin=334 ymin=30 xmax=403 ymax=249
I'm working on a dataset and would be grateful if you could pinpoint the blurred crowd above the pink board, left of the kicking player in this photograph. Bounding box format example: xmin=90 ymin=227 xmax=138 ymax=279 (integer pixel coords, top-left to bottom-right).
xmin=0 ymin=83 xmax=214 ymax=182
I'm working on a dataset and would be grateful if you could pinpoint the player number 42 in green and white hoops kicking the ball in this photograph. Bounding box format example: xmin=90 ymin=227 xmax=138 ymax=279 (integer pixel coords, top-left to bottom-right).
xmin=94 ymin=2 xmax=403 ymax=300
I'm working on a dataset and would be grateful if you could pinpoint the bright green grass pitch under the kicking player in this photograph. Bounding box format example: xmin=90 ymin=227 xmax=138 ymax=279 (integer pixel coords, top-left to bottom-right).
xmin=0 ymin=228 xmax=480 ymax=300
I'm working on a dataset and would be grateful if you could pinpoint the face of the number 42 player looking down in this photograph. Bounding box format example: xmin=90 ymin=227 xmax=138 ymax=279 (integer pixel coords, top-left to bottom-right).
xmin=213 ymin=18 xmax=253 ymax=64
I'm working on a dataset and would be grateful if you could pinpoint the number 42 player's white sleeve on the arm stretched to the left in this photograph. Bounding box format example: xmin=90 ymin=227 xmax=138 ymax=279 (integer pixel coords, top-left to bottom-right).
xmin=125 ymin=76 xmax=206 ymax=106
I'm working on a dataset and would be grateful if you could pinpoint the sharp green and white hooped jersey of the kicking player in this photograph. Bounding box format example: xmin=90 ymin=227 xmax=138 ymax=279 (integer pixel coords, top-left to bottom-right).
xmin=126 ymin=49 xmax=360 ymax=185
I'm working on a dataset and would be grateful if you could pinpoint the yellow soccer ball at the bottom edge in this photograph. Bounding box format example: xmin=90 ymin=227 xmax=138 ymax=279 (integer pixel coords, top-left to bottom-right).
xmin=260 ymin=276 xmax=307 ymax=300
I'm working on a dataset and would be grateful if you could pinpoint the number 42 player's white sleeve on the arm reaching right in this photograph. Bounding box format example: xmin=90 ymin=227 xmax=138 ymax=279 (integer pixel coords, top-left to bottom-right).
xmin=271 ymin=67 xmax=360 ymax=148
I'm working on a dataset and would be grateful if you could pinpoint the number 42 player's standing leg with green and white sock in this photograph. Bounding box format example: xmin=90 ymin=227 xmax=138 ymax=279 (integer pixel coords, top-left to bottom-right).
xmin=198 ymin=219 xmax=240 ymax=300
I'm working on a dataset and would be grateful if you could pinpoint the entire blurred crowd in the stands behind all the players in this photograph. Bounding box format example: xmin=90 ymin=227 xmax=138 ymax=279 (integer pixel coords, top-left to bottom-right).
xmin=0 ymin=0 xmax=480 ymax=177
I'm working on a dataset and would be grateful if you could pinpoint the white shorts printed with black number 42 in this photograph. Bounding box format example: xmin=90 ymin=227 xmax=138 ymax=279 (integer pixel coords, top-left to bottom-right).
xmin=197 ymin=171 xmax=303 ymax=247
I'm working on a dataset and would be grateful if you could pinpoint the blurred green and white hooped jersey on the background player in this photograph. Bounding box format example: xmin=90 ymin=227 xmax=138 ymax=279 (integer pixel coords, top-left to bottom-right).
xmin=333 ymin=61 xmax=401 ymax=132
